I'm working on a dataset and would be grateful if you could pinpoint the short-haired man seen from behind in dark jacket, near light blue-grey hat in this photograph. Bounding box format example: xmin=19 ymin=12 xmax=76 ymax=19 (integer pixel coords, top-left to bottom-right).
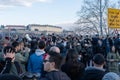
xmin=83 ymin=54 xmax=106 ymax=80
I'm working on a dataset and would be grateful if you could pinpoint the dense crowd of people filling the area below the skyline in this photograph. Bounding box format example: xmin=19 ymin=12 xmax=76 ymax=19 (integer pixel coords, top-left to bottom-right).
xmin=0 ymin=33 xmax=120 ymax=80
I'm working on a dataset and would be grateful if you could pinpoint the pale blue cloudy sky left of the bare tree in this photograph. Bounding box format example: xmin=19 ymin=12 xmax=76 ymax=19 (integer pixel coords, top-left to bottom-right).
xmin=0 ymin=0 xmax=82 ymax=25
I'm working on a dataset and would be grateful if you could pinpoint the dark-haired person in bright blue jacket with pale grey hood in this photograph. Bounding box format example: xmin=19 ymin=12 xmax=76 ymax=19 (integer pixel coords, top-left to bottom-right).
xmin=27 ymin=41 xmax=45 ymax=76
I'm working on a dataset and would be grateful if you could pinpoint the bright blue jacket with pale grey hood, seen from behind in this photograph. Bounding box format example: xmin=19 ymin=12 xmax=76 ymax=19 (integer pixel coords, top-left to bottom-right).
xmin=27 ymin=49 xmax=45 ymax=73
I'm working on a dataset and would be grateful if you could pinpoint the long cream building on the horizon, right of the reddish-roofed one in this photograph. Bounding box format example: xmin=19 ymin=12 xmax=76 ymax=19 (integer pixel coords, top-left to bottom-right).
xmin=26 ymin=24 xmax=63 ymax=33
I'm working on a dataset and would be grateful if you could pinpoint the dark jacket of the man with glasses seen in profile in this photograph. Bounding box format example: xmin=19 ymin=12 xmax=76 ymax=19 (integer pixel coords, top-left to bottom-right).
xmin=40 ymin=71 xmax=71 ymax=80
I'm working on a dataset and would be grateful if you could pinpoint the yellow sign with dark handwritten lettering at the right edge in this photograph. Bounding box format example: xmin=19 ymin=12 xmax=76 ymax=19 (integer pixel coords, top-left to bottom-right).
xmin=108 ymin=8 xmax=120 ymax=28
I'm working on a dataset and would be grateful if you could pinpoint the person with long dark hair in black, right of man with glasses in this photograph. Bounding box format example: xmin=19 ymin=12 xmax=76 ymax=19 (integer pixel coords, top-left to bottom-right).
xmin=61 ymin=49 xmax=85 ymax=80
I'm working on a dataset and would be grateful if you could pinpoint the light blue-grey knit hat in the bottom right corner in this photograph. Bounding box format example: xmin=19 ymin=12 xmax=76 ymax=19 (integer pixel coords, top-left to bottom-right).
xmin=102 ymin=72 xmax=120 ymax=80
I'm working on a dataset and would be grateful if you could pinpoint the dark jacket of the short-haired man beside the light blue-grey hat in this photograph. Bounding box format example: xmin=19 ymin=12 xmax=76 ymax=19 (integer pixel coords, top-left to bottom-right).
xmin=83 ymin=67 xmax=106 ymax=80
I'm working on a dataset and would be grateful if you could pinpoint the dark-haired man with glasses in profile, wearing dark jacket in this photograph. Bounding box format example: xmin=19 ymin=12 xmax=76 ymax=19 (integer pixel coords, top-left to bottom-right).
xmin=40 ymin=52 xmax=71 ymax=80
